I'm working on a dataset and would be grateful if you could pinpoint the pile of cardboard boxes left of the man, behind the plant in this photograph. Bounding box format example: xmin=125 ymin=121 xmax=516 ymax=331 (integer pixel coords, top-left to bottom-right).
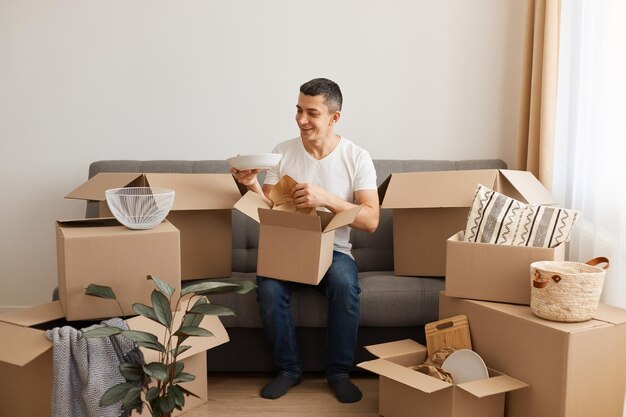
xmin=0 ymin=173 xmax=241 ymax=417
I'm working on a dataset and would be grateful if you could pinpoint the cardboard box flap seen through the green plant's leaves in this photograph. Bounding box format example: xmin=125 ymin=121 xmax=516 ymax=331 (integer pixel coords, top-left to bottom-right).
xmin=127 ymin=298 xmax=230 ymax=363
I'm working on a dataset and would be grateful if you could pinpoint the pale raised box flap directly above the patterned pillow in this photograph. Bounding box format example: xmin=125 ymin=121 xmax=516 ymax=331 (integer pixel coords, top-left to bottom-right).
xmin=494 ymin=169 xmax=557 ymax=205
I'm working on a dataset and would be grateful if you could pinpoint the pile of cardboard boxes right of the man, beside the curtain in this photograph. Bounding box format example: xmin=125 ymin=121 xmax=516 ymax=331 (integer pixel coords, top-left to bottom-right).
xmin=359 ymin=170 xmax=626 ymax=417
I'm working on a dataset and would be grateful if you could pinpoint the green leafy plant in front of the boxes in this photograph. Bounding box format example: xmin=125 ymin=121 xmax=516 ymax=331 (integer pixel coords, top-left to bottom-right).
xmin=81 ymin=275 xmax=256 ymax=417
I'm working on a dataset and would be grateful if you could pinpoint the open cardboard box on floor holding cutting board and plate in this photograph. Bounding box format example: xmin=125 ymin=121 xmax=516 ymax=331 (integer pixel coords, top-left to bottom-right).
xmin=358 ymin=339 xmax=527 ymax=417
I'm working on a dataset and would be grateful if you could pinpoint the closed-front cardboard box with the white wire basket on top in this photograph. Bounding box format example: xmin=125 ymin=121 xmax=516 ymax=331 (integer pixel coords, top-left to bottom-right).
xmin=56 ymin=218 xmax=180 ymax=320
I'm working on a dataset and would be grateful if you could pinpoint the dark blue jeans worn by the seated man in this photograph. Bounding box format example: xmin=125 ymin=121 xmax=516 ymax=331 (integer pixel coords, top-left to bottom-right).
xmin=257 ymin=251 xmax=361 ymax=379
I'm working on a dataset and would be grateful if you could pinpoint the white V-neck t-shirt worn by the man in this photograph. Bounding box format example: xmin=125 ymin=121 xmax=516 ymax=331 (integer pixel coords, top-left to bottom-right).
xmin=264 ymin=137 xmax=376 ymax=256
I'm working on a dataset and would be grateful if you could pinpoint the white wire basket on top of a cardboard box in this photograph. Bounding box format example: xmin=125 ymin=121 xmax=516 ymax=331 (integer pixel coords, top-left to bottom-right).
xmin=105 ymin=187 xmax=175 ymax=230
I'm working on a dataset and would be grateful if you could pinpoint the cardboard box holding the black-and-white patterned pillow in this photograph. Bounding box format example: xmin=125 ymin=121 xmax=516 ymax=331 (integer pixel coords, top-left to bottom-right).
xmin=445 ymin=231 xmax=565 ymax=305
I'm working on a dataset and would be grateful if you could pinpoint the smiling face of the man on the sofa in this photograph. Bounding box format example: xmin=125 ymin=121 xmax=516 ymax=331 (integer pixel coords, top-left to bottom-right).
xmin=296 ymin=93 xmax=340 ymax=141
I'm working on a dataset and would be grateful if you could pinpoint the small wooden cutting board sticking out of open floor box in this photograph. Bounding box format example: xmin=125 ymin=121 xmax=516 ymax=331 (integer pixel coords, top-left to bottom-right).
xmin=424 ymin=315 xmax=472 ymax=356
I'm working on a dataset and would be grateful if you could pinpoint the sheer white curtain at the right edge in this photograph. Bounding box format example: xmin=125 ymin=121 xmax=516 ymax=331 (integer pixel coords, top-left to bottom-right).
xmin=553 ymin=0 xmax=626 ymax=308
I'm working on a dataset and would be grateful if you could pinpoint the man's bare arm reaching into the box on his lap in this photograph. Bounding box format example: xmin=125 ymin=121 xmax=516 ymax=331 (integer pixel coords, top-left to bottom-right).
xmin=290 ymin=184 xmax=380 ymax=233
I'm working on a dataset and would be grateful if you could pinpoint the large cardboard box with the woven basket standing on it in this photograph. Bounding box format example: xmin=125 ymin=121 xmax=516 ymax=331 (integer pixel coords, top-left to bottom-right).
xmin=439 ymin=293 xmax=626 ymax=417
